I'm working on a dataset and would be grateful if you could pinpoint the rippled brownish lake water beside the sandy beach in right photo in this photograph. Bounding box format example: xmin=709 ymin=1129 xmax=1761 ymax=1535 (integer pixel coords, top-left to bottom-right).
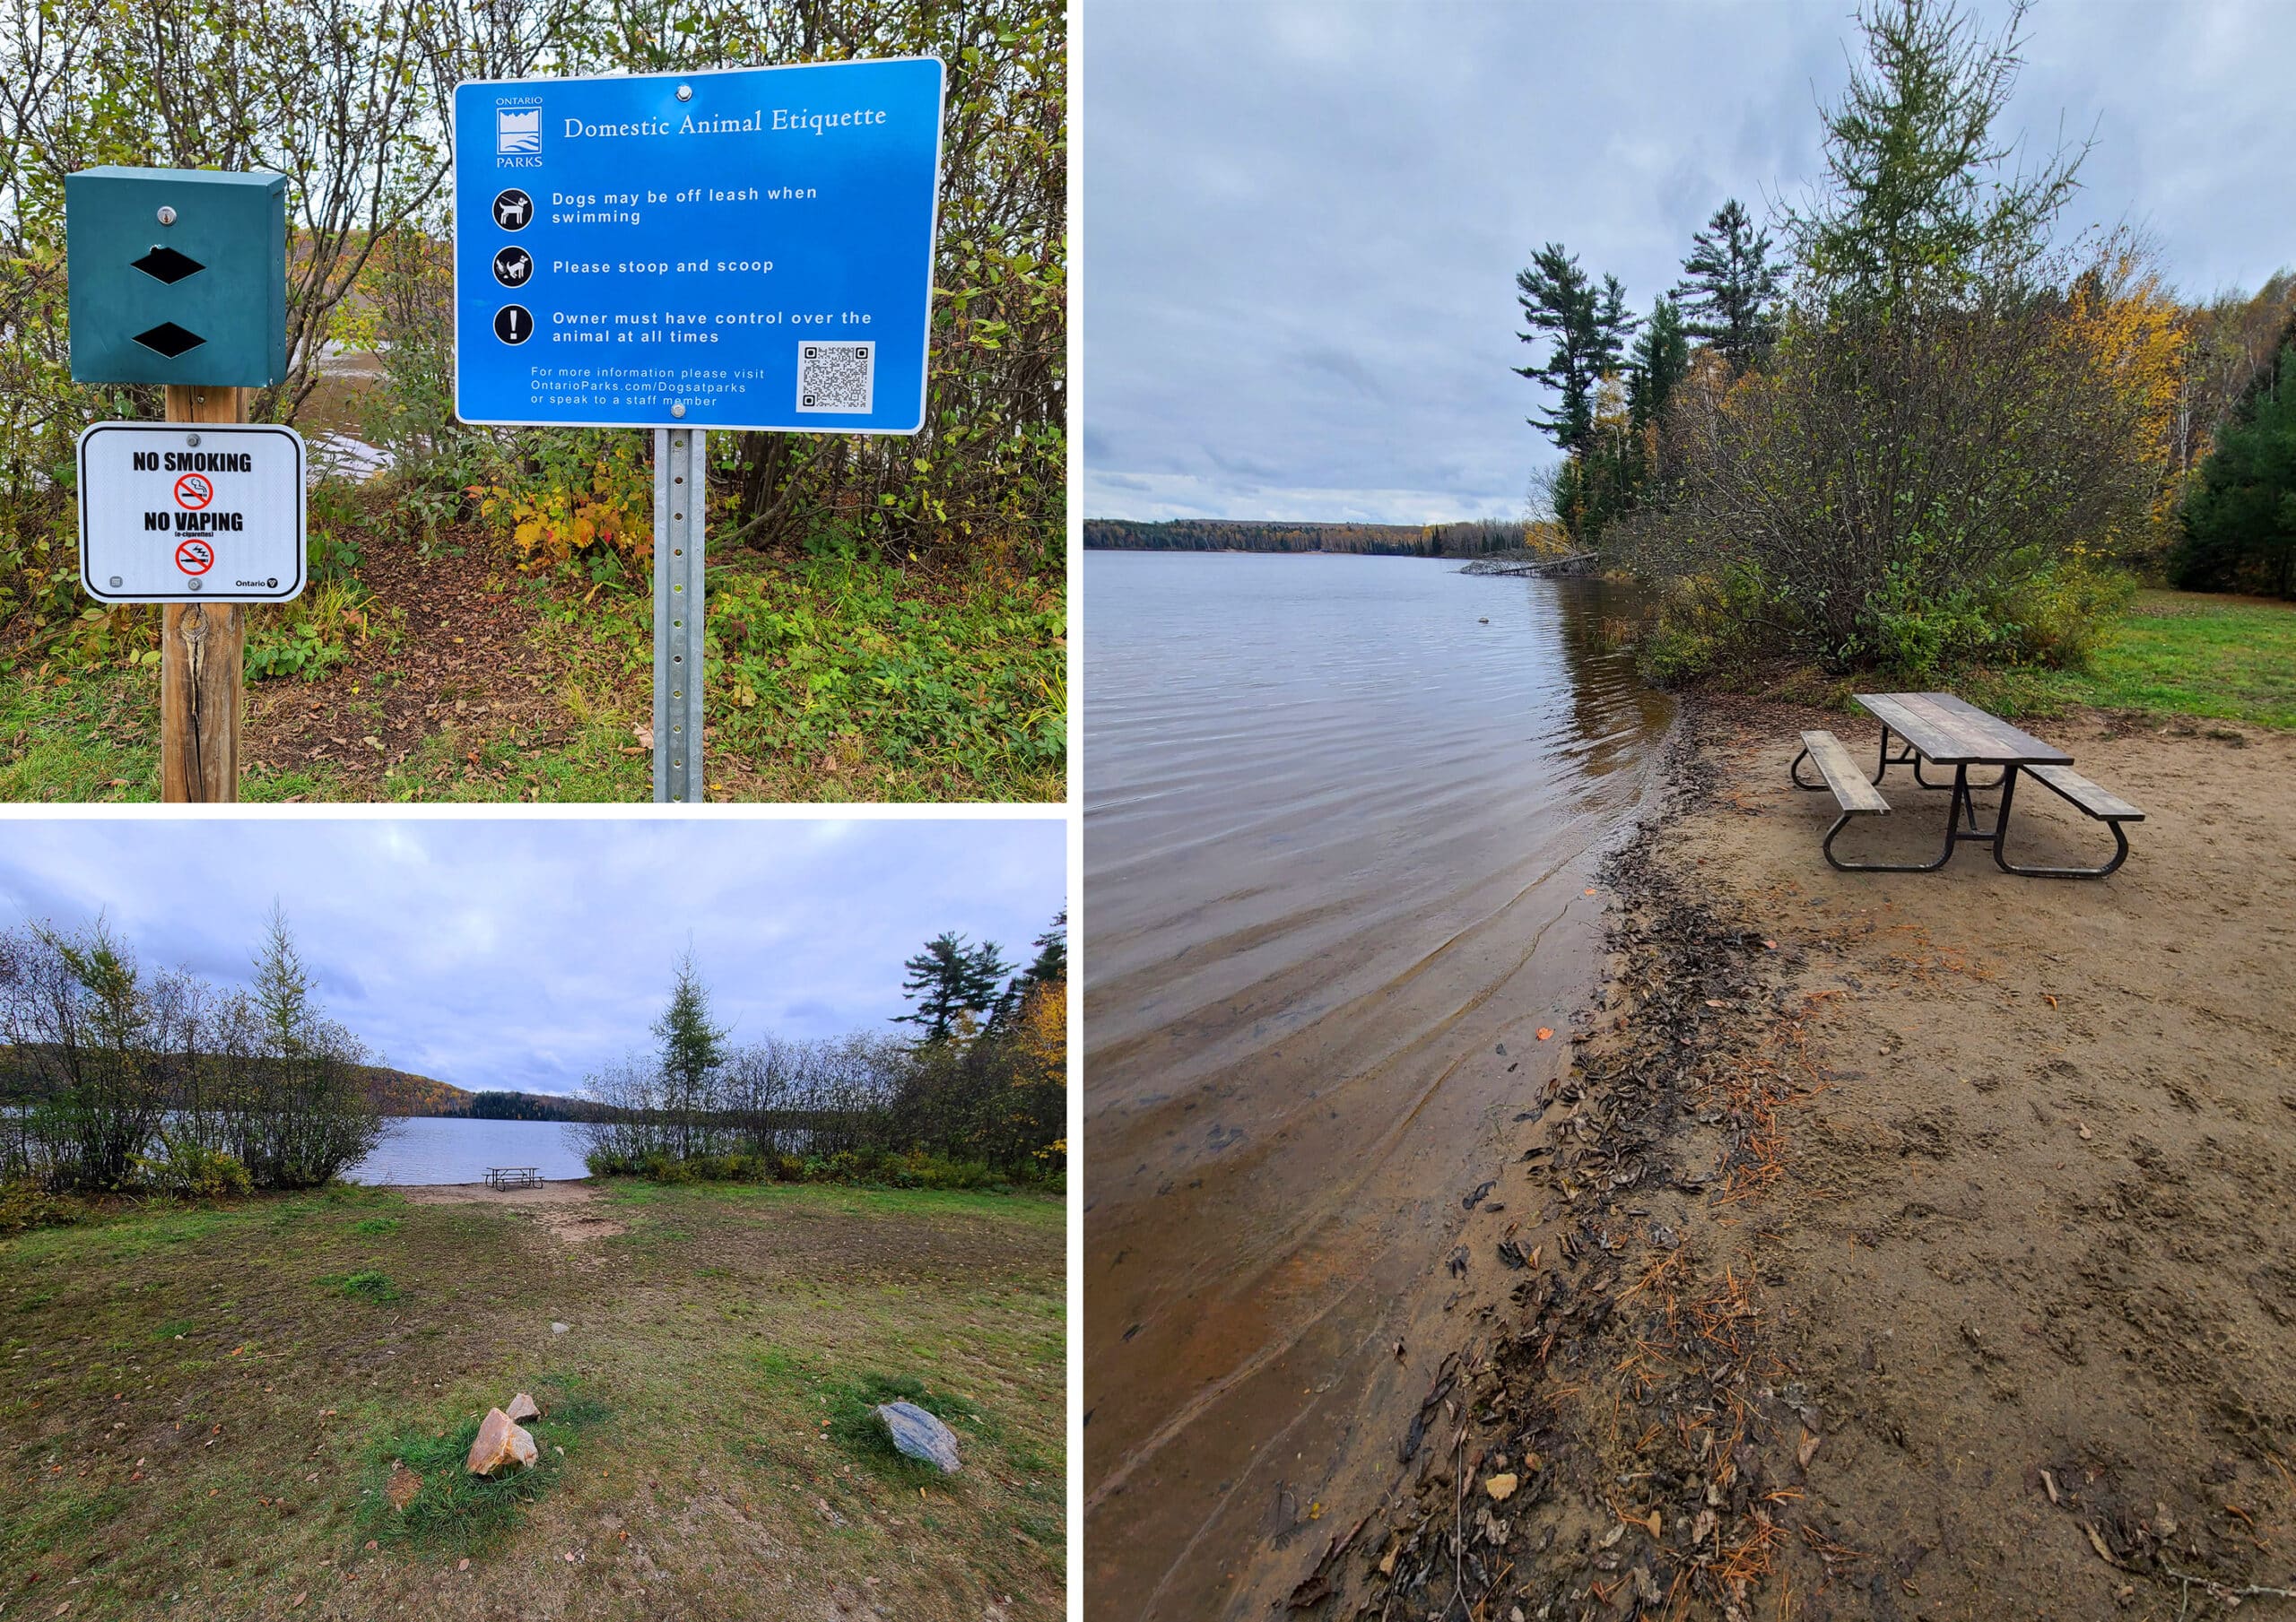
xmin=1083 ymin=553 xmax=1672 ymax=1619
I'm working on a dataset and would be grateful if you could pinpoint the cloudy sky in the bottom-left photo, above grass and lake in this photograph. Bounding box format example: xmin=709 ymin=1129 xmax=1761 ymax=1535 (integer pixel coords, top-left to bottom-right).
xmin=0 ymin=819 xmax=1065 ymax=1092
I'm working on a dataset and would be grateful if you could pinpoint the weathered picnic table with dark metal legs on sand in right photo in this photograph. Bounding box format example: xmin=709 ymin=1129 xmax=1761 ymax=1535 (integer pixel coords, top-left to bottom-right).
xmin=1787 ymin=693 xmax=2144 ymax=879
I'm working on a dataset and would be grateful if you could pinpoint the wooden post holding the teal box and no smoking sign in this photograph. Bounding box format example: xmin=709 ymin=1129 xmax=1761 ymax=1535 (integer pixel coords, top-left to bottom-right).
xmin=159 ymin=383 xmax=248 ymax=805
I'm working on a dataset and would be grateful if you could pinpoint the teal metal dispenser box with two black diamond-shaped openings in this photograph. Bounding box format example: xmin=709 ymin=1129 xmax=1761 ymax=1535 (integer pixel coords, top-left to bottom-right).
xmin=65 ymin=165 xmax=287 ymax=387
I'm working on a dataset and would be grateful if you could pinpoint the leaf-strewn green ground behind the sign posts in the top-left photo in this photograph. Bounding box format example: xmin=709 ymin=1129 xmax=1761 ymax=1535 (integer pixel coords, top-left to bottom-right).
xmin=0 ymin=516 xmax=1067 ymax=803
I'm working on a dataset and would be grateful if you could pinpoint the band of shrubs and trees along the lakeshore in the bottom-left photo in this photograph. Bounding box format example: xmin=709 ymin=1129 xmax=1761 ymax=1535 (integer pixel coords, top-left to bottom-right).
xmin=0 ymin=906 xmax=1067 ymax=1229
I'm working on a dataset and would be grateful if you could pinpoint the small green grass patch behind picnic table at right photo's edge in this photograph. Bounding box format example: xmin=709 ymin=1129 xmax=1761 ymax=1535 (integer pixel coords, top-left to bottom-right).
xmin=1963 ymin=592 xmax=2296 ymax=730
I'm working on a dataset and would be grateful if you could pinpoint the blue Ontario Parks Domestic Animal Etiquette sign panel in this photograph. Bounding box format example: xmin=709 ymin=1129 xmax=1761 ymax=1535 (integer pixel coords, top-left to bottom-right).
xmin=455 ymin=57 xmax=944 ymax=434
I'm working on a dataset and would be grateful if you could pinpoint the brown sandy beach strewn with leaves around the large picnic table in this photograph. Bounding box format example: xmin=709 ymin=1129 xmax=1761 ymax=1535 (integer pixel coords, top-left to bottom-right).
xmin=1322 ymin=702 xmax=2296 ymax=1622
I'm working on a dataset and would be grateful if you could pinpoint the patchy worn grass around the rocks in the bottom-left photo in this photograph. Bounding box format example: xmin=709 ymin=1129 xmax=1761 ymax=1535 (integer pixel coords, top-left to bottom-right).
xmin=0 ymin=1184 xmax=1065 ymax=1622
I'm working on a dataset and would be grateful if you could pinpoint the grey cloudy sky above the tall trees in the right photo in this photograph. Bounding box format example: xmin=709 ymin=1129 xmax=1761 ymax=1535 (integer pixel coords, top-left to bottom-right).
xmin=1079 ymin=0 xmax=2296 ymax=523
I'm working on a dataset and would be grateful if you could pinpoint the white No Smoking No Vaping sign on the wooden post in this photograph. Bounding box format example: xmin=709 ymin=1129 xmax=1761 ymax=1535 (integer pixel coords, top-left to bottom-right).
xmin=81 ymin=422 xmax=303 ymax=603
